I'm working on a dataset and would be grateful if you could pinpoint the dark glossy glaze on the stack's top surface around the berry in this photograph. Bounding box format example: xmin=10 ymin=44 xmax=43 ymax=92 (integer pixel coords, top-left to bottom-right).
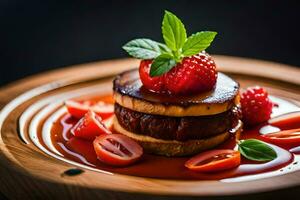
xmin=113 ymin=70 xmax=239 ymax=106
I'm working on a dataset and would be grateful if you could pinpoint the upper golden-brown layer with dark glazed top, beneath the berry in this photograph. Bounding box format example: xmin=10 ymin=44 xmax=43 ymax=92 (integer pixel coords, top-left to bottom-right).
xmin=113 ymin=70 xmax=239 ymax=117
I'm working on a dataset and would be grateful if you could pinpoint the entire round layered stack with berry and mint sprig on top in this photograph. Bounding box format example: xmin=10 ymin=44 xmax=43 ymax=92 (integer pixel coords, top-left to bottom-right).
xmin=113 ymin=12 xmax=241 ymax=156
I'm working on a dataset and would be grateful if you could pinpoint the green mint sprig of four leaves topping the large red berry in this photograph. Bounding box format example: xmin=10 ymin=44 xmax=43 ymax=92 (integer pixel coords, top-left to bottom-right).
xmin=123 ymin=11 xmax=217 ymax=76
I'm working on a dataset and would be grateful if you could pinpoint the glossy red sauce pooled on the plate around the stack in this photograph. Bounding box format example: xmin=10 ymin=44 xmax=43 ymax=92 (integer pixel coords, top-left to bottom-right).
xmin=51 ymin=96 xmax=300 ymax=180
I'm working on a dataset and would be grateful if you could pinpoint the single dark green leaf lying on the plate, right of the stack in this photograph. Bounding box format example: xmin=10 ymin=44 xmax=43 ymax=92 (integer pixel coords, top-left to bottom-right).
xmin=238 ymin=139 xmax=277 ymax=161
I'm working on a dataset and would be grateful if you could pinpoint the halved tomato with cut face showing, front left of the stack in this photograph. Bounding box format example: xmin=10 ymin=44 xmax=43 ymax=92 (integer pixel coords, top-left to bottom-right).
xmin=94 ymin=134 xmax=143 ymax=166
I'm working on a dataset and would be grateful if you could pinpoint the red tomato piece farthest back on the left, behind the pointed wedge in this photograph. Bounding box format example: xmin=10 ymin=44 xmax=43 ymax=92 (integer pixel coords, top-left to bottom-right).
xmin=65 ymin=100 xmax=114 ymax=119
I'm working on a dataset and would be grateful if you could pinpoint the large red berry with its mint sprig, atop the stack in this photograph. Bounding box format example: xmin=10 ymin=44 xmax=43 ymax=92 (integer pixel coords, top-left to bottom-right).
xmin=123 ymin=11 xmax=217 ymax=95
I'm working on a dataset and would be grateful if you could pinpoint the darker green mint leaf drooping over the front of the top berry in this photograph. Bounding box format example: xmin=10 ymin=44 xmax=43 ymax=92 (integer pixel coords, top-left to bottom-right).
xmin=150 ymin=54 xmax=176 ymax=77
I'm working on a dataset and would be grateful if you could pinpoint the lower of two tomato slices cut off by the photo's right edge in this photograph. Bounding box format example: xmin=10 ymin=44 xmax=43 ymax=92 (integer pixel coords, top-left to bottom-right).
xmin=261 ymin=128 xmax=300 ymax=144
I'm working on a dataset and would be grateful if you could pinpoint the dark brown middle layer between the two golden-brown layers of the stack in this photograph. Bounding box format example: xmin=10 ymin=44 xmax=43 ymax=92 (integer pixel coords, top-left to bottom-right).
xmin=115 ymin=103 xmax=240 ymax=141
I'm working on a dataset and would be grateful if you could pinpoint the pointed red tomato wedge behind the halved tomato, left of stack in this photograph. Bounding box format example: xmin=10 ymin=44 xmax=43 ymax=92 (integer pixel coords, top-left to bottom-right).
xmin=71 ymin=111 xmax=111 ymax=140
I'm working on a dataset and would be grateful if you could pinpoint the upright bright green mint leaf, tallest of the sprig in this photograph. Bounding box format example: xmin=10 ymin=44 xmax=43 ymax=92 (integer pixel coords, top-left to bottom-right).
xmin=162 ymin=11 xmax=186 ymax=52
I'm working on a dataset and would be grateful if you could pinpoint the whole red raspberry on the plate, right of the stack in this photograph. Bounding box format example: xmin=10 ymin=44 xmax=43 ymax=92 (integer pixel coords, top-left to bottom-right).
xmin=241 ymin=86 xmax=274 ymax=126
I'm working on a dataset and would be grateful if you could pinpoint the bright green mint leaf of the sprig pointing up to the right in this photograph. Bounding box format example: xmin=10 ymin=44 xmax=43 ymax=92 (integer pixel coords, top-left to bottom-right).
xmin=182 ymin=31 xmax=217 ymax=56
